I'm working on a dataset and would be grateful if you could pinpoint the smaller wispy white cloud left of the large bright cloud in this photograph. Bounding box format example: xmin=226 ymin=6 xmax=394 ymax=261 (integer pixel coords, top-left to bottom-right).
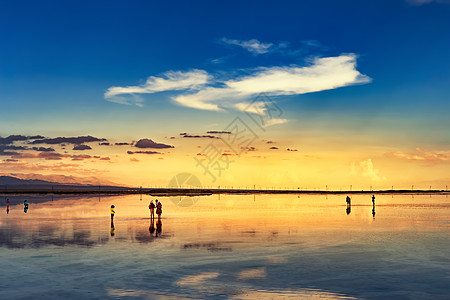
xmin=105 ymin=70 xmax=210 ymax=99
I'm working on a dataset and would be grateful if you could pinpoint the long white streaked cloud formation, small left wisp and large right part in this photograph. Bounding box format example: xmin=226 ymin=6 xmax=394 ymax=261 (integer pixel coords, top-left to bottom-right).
xmin=105 ymin=54 xmax=371 ymax=111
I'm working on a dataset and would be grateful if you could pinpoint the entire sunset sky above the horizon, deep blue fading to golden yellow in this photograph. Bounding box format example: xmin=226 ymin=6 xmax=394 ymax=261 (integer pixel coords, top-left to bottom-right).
xmin=0 ymin=0 xmax=450 ymax=189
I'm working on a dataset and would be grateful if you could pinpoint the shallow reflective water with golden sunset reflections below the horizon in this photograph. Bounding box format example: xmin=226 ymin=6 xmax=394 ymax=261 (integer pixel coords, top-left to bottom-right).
xmin=0 ymin=195 xmax=450 ymax=299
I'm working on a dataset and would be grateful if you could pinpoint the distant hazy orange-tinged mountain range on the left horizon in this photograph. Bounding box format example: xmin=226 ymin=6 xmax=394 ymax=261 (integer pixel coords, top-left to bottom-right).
xmin=0 ymin=173 xmax=121 ymax=186
